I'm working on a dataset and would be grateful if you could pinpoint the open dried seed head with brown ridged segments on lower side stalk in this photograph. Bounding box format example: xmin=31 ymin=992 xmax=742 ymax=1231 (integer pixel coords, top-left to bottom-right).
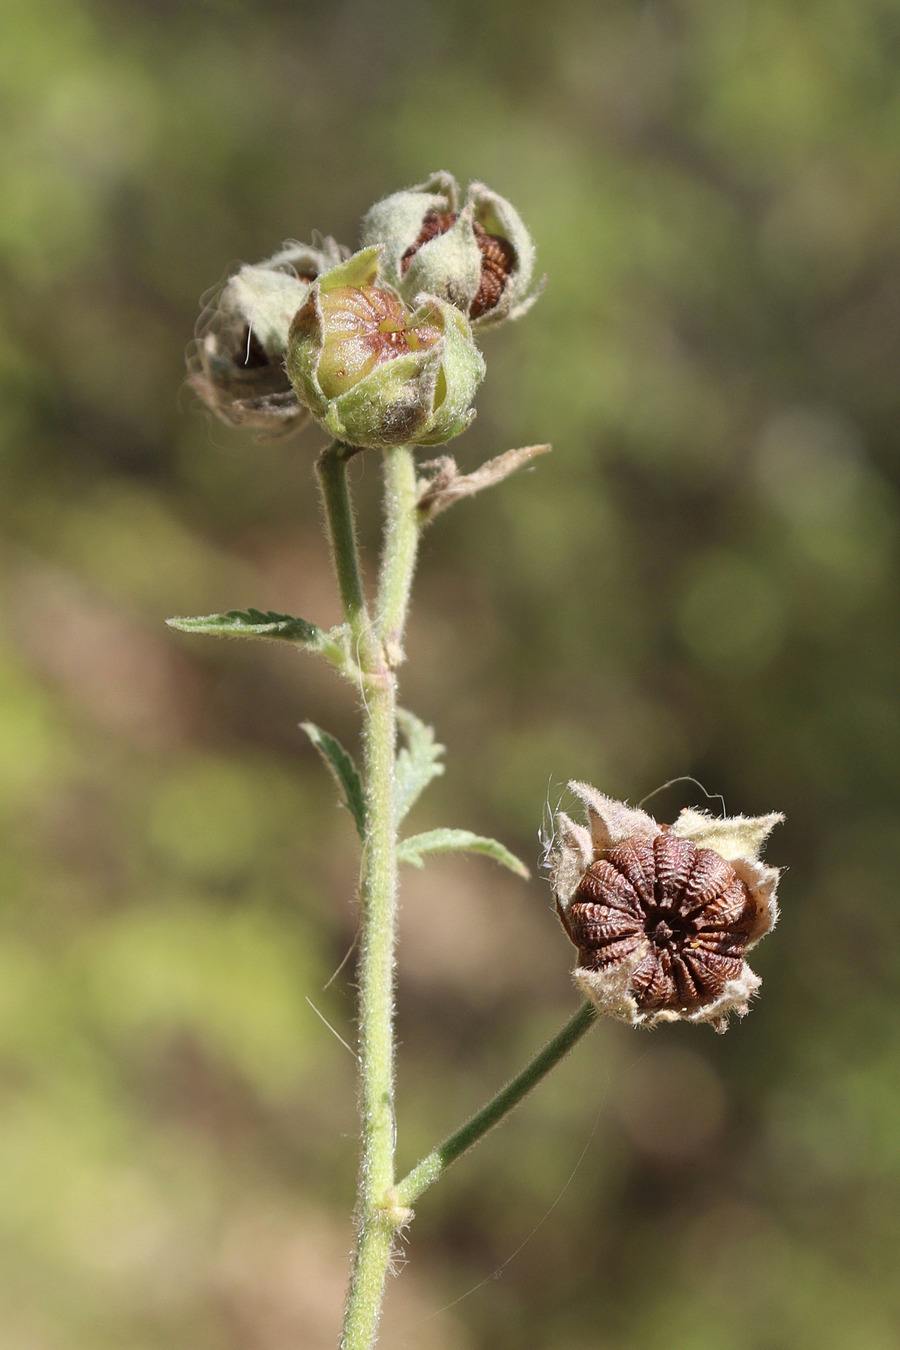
xmin=551 ymin=783 xmax=783 ymax=1031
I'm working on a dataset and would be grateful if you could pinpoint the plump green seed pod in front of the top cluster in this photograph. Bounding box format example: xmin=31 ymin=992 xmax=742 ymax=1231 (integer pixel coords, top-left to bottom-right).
xmin=286 ymin=247 xmax=484 ymax=448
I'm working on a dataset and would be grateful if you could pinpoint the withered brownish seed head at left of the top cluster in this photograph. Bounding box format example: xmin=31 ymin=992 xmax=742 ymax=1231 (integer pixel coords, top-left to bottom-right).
xmin=186 ymin=239 xmax=347 ymax=436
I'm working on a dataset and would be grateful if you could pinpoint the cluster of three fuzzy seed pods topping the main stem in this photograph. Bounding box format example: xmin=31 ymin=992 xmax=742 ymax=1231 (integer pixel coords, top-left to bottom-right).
xmin=188 ymin=173 xmax=540 ymax=448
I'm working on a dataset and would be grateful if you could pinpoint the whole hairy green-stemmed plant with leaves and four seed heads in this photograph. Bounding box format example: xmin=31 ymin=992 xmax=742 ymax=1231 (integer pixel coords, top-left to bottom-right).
xmin=170 ymin=173 xmax=781 ymax=1350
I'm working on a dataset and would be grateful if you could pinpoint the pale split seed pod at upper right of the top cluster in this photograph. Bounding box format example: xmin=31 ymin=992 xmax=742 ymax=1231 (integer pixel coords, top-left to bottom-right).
xmin=362 ymin=173 xmax=542 ymax=328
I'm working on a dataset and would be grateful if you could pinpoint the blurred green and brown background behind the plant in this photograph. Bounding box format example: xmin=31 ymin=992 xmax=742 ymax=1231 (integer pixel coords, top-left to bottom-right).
xmin=0 ymin=0 xmax=900 ymax=1350
